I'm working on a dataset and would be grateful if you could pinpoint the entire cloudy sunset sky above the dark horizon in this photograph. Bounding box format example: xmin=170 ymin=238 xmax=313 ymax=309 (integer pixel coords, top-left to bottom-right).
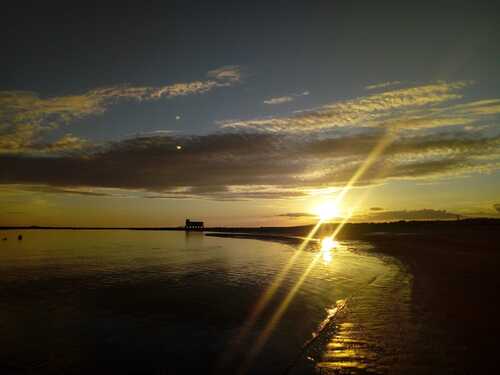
xmin=0 ymin=0 xmax=500 ymax=227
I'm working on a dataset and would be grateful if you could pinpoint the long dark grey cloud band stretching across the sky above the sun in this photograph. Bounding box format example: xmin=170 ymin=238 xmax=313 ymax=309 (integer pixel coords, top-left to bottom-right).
xmin=0 ymin=127 xmax=500 ymax=199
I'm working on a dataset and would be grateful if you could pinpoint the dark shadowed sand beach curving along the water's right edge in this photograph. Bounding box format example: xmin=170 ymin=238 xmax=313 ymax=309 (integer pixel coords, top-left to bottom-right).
xmin=367 ymin=230 xmax=500 ymax=374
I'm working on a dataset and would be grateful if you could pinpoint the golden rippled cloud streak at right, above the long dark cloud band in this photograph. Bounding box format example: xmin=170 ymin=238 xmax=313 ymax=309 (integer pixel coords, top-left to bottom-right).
xmin=220 ymin=81 xmax=472 ymax=133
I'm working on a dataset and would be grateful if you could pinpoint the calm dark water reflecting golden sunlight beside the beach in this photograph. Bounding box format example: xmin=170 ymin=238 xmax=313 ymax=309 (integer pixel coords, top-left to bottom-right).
xmin=0 ymin=230 xmax=413 ymax=374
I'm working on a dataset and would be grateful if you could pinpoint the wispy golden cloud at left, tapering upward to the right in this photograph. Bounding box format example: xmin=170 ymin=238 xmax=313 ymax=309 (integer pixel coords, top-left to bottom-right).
xmin=0 ymin=66 xmax=241 ymax=153
